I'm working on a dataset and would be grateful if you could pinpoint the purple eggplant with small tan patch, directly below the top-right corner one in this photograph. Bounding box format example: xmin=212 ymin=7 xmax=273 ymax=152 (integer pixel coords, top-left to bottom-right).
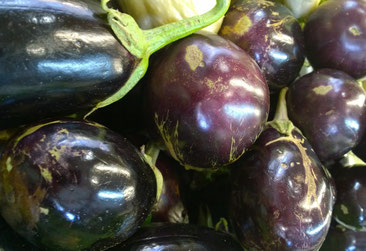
xmin=287 ymin=69 xmax=366 ymax=161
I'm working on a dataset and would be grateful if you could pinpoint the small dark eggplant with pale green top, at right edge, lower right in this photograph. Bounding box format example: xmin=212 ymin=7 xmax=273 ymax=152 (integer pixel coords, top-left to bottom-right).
xmin=329 ymin=152 xmax=366 ymax=231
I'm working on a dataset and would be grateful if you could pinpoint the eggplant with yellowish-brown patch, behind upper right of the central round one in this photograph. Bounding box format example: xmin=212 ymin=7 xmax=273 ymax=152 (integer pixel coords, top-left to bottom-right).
xmin=219 ymin=0 xmax=305 ymax=92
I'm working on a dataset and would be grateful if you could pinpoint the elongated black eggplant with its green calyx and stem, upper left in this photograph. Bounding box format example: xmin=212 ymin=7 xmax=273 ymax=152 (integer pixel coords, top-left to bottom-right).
xmin=0 ymin=0 xmax=229 ymax=128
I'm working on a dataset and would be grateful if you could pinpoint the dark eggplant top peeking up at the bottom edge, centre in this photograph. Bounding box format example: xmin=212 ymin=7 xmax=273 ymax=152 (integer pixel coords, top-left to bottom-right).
xmin=111 ymin=223 xmax=243 ymax=251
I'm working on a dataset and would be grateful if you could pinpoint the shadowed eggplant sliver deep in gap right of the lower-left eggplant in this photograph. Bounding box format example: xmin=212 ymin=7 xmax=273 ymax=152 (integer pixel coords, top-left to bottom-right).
xmin=151 ymin=152 xmax=188 ymax=223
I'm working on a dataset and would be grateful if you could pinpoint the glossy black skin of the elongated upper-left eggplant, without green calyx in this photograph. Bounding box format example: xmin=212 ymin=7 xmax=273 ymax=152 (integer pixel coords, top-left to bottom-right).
xmin=0 ymin=0 xmax=137 ymax=128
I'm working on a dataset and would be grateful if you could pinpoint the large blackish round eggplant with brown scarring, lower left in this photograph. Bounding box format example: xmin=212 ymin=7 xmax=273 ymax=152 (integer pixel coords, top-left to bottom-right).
xmin=0 ymin=120 xmax=156 ymax=250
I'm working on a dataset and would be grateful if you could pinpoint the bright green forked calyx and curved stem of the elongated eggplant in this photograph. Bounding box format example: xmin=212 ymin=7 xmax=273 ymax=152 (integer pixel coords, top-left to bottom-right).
xmin=85 ymin=0 xmax=230 ymax=117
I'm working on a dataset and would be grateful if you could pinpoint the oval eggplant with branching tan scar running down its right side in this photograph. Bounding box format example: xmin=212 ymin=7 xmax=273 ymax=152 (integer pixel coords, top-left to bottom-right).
xmin=230 ymin=124 xmax=334 ymax=250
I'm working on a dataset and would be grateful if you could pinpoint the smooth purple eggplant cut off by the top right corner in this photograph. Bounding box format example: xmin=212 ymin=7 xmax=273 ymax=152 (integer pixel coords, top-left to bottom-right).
xmin=304 ymin=0 xmax=366 ymax=78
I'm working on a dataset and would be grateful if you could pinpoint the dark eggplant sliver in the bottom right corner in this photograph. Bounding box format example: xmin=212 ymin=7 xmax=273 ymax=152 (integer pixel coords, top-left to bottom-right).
xmin=320 ymin=222 xmax=366 ymax=251
